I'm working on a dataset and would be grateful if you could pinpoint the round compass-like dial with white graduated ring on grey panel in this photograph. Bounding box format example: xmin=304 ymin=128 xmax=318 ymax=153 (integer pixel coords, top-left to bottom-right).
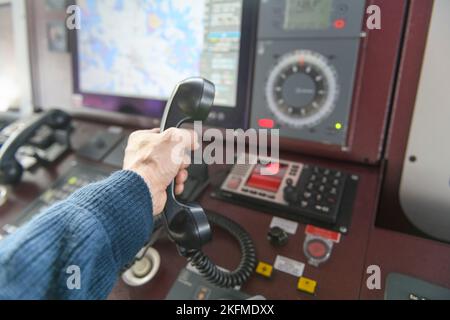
xmin=266 ymin=50 xmax=339 ymax=129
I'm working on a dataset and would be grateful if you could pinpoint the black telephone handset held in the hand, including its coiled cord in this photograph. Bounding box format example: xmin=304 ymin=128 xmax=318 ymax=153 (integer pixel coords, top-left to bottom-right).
xmin=161 ymin=78 xmax=256 ymax=288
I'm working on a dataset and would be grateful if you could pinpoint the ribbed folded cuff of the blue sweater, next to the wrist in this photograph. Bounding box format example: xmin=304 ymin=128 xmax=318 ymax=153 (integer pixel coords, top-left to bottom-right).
xmin=69 ymin=171 xmax=153 ymax=268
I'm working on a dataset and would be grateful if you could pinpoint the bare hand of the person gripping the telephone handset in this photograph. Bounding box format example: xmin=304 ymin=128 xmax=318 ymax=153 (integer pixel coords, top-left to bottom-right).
xmin=123 ymin=128 xmax=199 ymax=216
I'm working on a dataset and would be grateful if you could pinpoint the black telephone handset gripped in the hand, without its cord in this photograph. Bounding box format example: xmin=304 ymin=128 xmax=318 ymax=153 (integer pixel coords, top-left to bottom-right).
xmin=161 ymin=78 xmax=215 ymax=252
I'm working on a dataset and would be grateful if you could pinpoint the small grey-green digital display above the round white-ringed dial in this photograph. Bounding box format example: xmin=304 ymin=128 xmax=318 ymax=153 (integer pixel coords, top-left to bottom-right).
xmin=284 ymin=0 xmax=333 ymax=30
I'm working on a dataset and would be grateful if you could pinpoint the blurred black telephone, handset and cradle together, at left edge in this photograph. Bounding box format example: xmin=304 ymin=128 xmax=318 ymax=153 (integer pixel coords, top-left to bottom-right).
xmin=0 ymin=110 xmax=71 ymax=185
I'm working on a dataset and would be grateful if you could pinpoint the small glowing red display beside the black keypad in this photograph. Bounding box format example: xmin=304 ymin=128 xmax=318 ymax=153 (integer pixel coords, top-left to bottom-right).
xmin=246 ymin=164 xmax=288 ymax=192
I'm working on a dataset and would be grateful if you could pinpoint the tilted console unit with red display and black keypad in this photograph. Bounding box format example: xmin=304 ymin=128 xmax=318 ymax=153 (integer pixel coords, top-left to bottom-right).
xmin=218 ymin=154 xmax=359 ymax=233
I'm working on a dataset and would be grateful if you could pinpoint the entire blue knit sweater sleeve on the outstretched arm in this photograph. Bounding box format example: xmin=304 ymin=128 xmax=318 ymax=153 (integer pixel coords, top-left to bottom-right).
xmin=0 ymin=171 xmax=153 ymax=300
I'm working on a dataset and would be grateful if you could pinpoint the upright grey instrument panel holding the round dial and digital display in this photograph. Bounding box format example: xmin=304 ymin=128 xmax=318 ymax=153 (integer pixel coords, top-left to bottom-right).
xmin=251 ymin=0 xmax=365 ymax=147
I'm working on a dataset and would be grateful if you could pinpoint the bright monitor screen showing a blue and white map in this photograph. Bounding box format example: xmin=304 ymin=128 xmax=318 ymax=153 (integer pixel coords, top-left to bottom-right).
xmin=77 ymin=0 xmax=242 ymax=107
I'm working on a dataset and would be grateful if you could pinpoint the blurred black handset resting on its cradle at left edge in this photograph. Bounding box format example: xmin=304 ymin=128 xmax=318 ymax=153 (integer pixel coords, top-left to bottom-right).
xmin=0 ymin=110 xmax=71 ymax=185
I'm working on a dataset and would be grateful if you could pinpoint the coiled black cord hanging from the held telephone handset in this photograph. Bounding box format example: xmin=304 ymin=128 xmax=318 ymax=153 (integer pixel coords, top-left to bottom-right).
xmin=186 ymin=211 xmax=257 ymax=288
